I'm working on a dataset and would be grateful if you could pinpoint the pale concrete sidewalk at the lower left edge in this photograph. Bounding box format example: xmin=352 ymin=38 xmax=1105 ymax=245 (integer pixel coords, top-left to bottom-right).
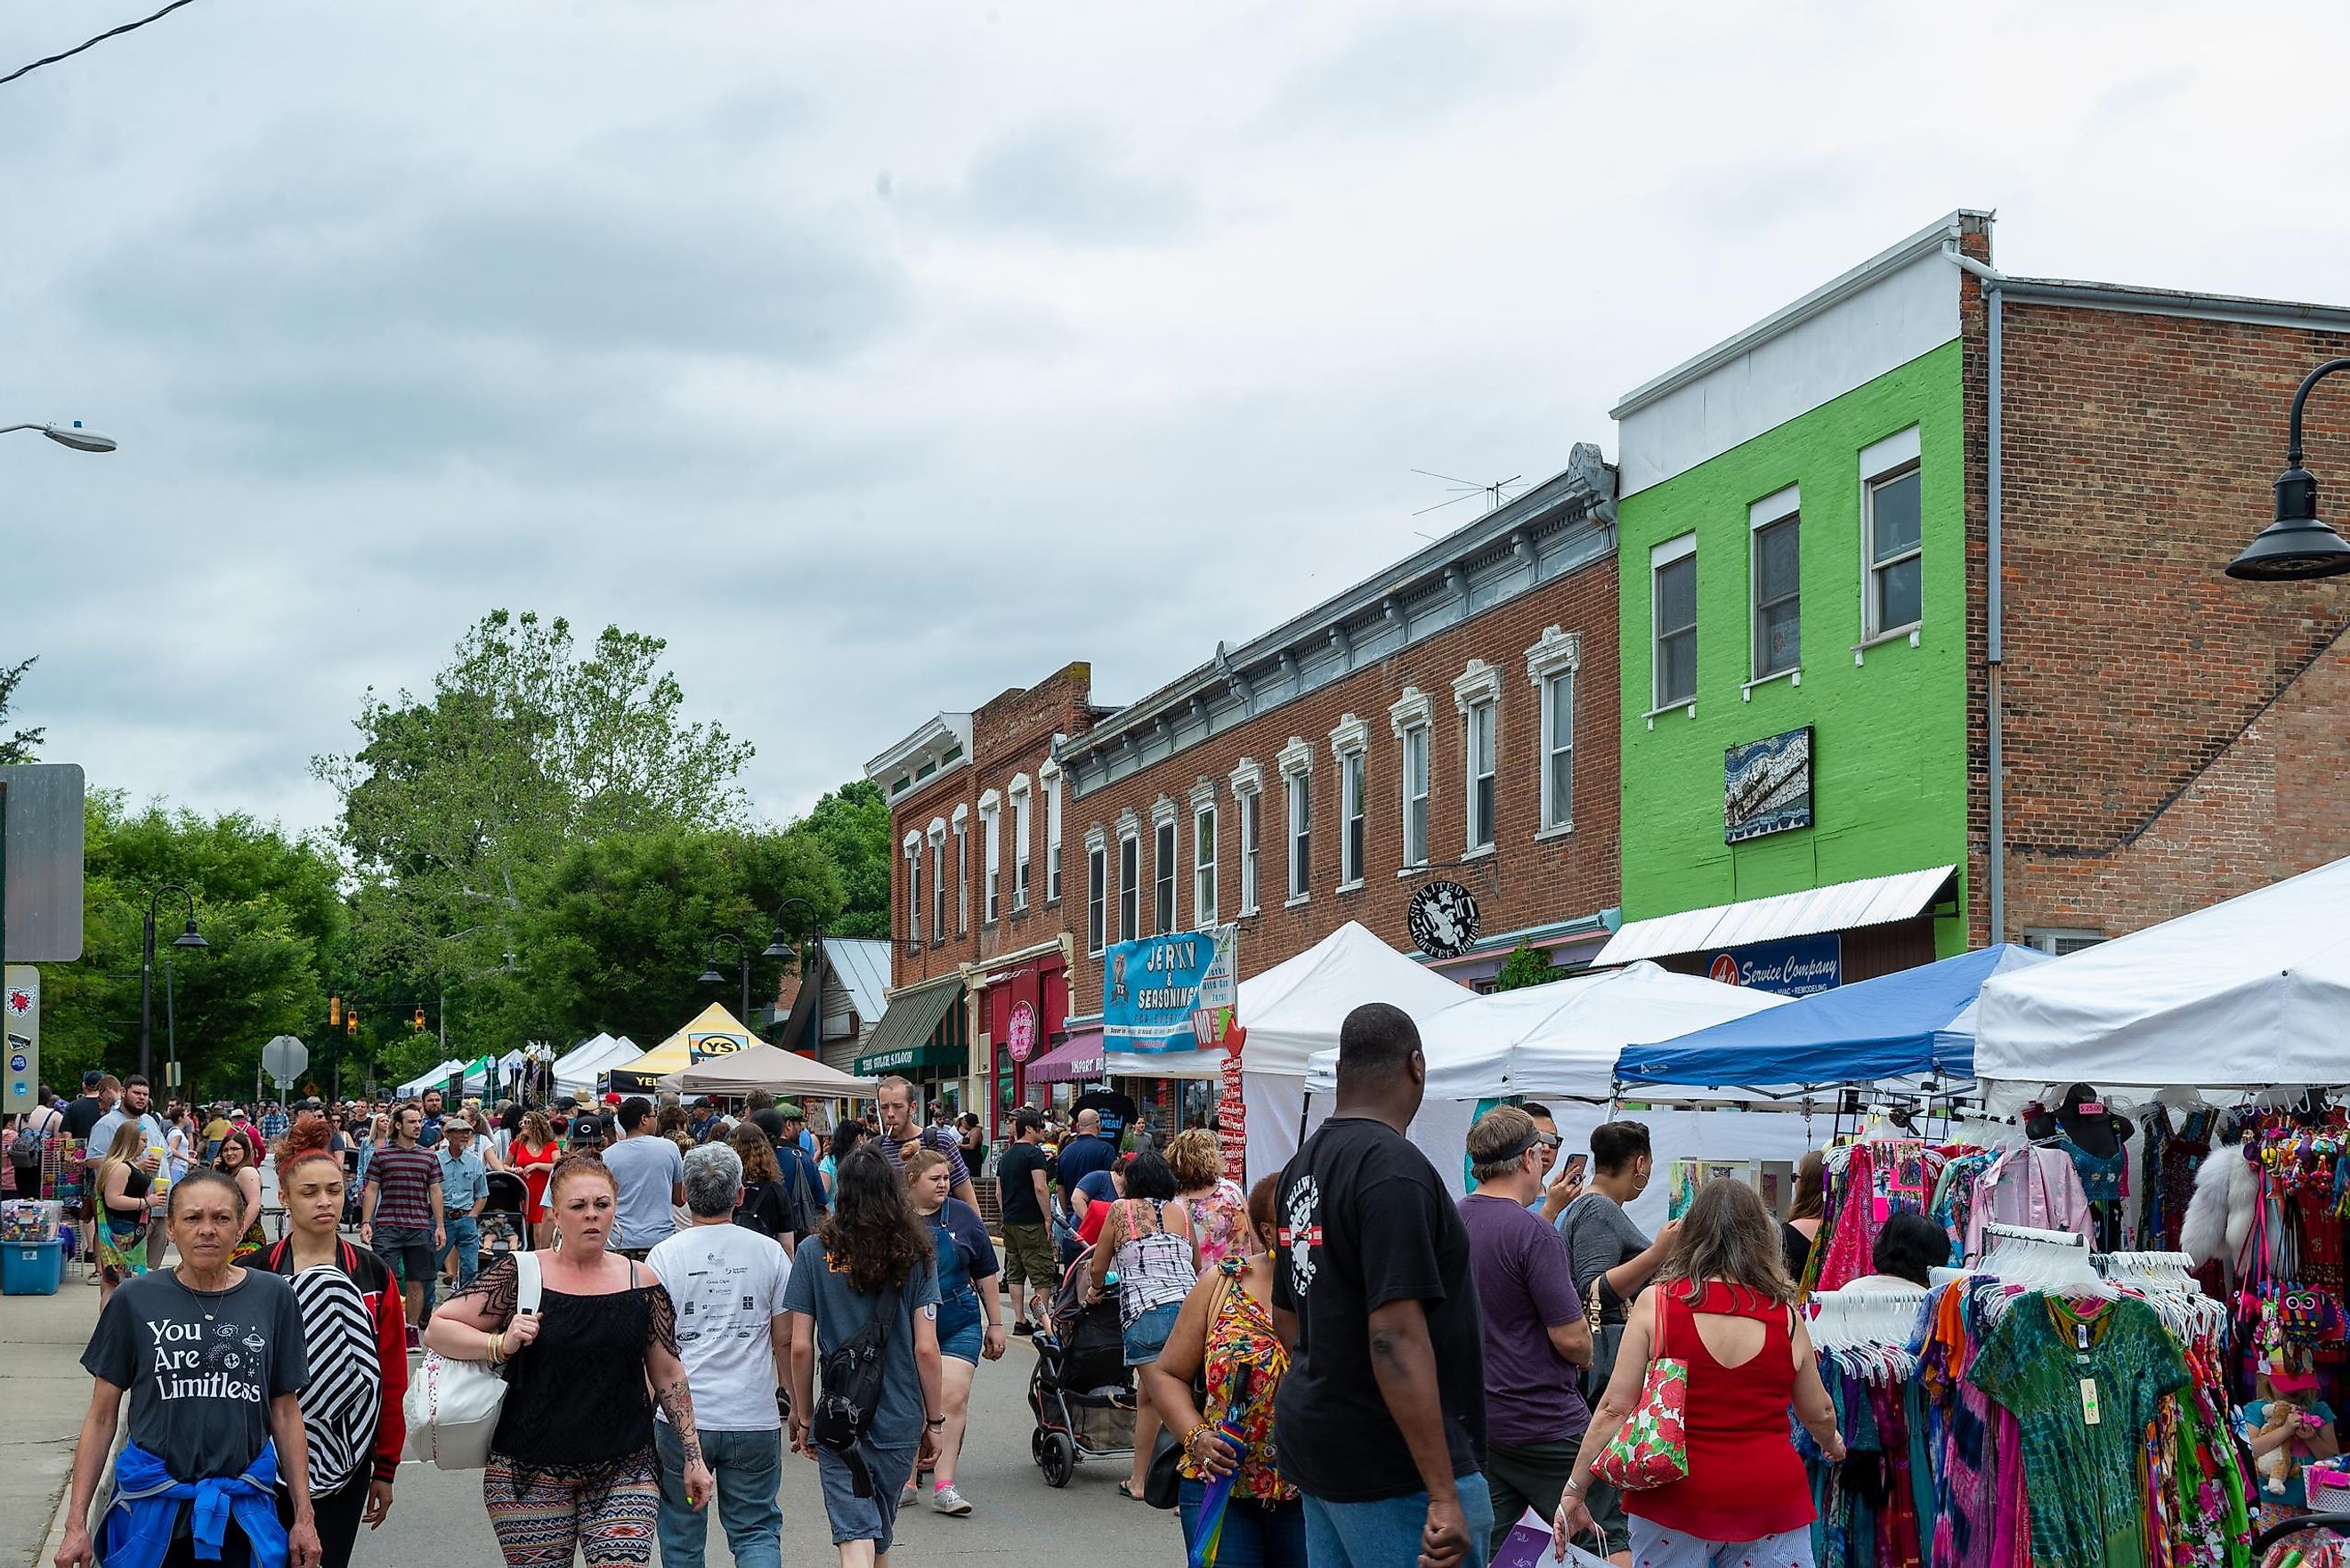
xmin=0 ymin=1265 xmax=99 ymax=1568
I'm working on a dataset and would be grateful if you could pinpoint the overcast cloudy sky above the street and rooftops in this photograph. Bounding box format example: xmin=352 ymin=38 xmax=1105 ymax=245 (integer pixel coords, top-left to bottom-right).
xmin=0 ymin=0 xmax=2350 ymax=828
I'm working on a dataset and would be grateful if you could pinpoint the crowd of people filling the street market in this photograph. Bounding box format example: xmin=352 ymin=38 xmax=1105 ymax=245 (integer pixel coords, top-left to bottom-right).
xmin=9 ymin=1020 xmax=1927 ymax=1568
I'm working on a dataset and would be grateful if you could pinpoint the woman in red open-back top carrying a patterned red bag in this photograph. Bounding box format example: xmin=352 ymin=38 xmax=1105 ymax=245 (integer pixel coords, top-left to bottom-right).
xmin=1553 ymin=1180 xmax=1844 ymax=1568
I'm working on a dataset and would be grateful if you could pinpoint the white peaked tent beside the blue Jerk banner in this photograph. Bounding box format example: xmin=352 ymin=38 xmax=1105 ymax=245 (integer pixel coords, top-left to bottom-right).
xmin=1231 ymin=919 xmax=1473 ymax=1180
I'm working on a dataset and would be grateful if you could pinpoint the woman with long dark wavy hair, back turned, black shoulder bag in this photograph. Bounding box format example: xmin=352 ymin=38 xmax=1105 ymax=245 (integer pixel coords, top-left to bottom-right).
xmin=782 ymin=1147 xmax=947 ymax=1568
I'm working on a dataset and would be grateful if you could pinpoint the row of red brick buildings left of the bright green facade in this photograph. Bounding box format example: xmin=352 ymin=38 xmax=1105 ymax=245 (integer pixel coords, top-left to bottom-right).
xmin=860 ymin=447 xmax=1617 ymax=1126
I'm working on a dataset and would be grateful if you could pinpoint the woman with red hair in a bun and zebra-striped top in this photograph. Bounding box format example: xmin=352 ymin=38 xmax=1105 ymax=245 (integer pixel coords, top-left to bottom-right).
xmin=256 ymin=1121 xmax=409 ymax=1568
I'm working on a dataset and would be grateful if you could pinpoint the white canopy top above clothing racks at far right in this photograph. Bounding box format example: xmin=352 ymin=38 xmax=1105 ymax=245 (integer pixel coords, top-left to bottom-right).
xmin=1974 ymin=858 xmax=2350 ymax=1107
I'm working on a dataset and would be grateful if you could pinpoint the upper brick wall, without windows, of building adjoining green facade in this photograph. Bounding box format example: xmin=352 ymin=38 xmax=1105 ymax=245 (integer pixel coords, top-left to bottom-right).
xmin=1065 ymin=554 xmax=1619 ymax=1015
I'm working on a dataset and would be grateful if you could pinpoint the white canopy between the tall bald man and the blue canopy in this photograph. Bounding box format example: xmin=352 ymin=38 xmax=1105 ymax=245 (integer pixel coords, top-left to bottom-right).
xmin=1306 ymin=961 xmax=1788 ymax=1100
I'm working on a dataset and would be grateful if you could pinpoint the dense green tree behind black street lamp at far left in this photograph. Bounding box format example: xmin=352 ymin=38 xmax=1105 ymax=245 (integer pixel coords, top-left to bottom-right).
xmin=43 ymin=790 xmax=345 ymax=1093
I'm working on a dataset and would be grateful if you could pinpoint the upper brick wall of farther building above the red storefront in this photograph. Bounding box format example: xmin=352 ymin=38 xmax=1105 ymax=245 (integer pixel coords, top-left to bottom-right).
xmin=891 ymin=663 xmax=1093 ymax=988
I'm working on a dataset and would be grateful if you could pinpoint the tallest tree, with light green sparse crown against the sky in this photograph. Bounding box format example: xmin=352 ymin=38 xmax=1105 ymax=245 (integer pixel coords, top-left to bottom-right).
xmin=310 ymin=609 xmax=752 ymax=994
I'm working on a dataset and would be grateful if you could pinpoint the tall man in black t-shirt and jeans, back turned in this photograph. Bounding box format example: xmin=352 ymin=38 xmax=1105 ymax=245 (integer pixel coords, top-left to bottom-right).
xmin=1274 ymin=1001 xmax=1492 ymax=1568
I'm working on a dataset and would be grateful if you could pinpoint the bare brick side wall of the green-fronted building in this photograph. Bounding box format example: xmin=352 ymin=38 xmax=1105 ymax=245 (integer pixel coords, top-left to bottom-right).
xmin=1969 ymin=298 xmax=2350 ymax=941
